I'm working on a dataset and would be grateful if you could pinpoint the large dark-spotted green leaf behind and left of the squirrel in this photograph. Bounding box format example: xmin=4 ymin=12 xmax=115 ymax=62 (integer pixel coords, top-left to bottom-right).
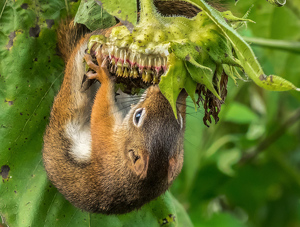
xmin=0 ymin=0 xmax=192 ymax=227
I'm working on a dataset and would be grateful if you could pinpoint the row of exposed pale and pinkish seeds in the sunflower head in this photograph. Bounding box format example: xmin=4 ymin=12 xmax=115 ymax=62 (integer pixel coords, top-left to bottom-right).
xmin=98 ymin=45 xmax=168 ymax=84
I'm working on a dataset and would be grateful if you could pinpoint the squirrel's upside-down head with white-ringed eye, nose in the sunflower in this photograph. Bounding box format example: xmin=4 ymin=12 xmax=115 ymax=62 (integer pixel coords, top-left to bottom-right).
xmin=119 ymin=85 xmax=186 ymax=187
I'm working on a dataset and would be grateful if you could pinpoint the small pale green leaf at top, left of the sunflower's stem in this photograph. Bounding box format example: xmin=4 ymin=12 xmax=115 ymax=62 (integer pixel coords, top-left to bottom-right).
xmin=74 ymin=1 xmax=116 ymax=31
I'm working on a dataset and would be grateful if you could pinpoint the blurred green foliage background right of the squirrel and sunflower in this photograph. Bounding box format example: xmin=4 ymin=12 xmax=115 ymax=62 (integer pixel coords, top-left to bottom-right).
xmin=171 ymin=0 xmax=300 ymax=227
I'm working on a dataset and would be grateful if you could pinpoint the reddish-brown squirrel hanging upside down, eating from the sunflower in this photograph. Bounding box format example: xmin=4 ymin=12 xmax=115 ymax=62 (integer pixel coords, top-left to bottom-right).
xmin=43 ymin=15 xmax=186 ymax=214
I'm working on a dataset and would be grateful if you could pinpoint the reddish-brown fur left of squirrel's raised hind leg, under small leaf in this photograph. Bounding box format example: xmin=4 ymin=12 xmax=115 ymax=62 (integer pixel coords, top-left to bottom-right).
xmin=57 ymin=18 xmax=90 ymax=63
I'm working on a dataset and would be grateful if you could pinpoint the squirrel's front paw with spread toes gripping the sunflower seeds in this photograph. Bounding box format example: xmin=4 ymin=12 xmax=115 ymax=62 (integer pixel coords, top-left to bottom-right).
xmin=84 ymin=51 xmax=110 ymax=83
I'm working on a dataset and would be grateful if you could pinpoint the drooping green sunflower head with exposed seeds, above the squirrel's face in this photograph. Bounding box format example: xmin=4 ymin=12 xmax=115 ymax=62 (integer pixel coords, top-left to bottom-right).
xmin=89 ymin=0 xmax=299 ymax=121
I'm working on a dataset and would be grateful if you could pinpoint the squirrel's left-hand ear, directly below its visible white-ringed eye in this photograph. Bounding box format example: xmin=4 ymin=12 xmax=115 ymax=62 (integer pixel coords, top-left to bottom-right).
xmin=129 ymin=150 xmax=149 ymax=179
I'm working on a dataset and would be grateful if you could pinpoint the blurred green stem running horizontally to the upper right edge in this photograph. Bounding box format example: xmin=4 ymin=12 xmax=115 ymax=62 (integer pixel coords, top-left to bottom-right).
xmin=243 ymin=37 xmax=300 ymax=53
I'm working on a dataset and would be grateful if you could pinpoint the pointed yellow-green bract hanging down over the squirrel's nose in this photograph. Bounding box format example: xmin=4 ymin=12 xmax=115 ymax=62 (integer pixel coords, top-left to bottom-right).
xmin=159 ymin=54 xmax=187 ymax=119
